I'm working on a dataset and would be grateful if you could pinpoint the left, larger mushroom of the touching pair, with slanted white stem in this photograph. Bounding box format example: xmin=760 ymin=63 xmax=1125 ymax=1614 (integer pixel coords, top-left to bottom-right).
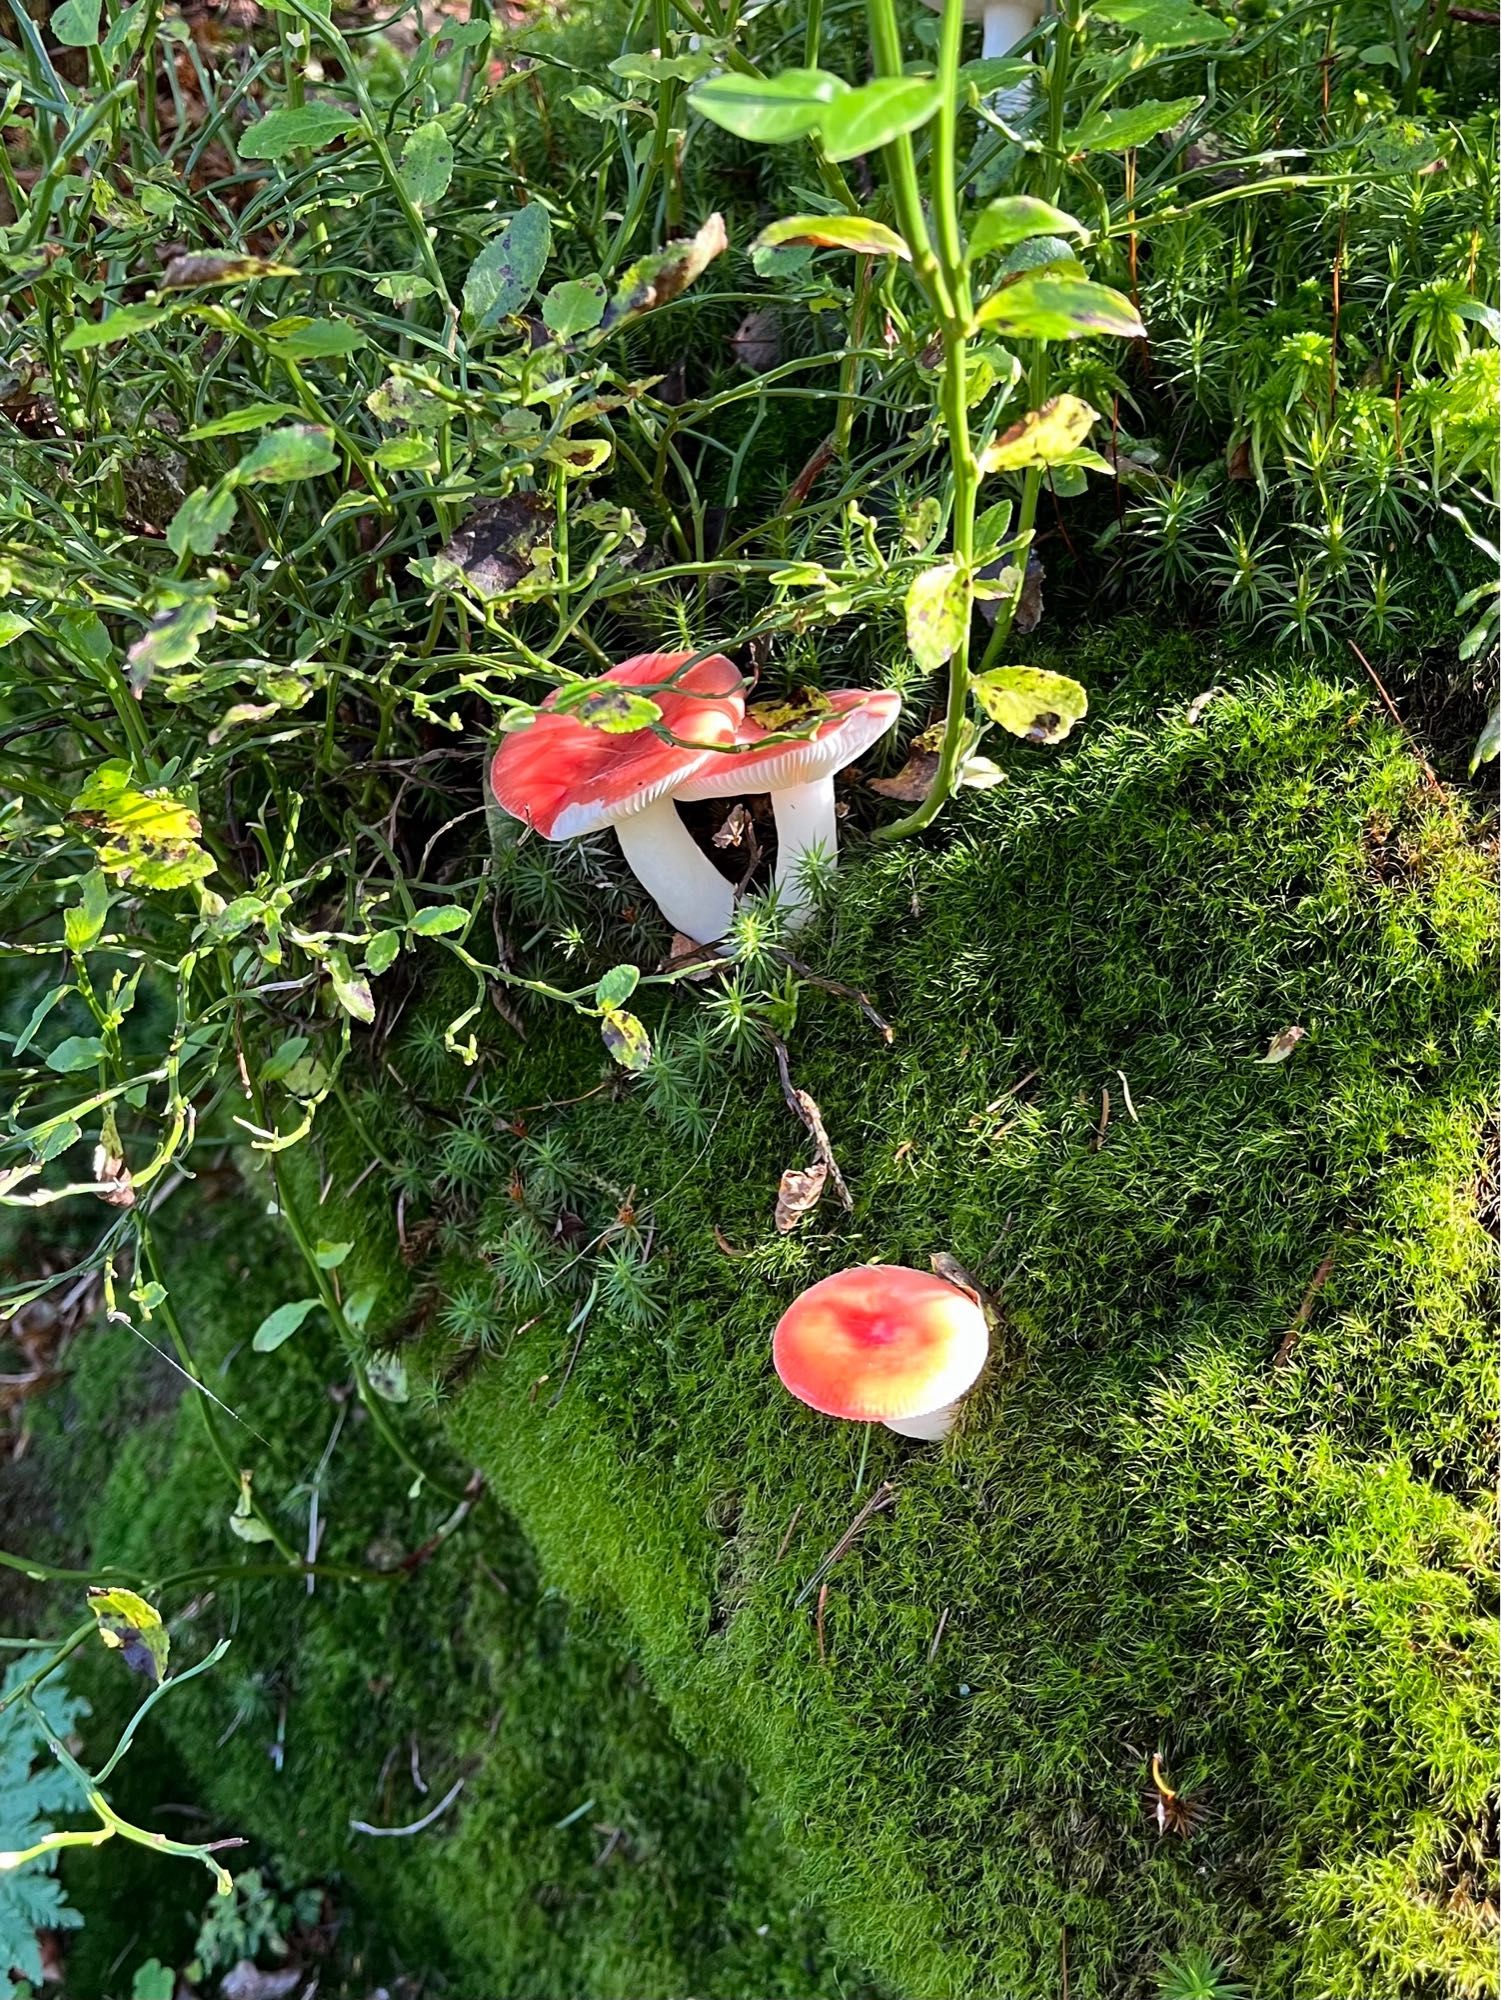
xmin=490 ymin=652 xmax=744 ymax=944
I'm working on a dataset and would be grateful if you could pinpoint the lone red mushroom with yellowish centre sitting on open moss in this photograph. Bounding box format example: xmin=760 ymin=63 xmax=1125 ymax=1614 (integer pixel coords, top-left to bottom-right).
xmin=773 ymin=1264 xmax=991 ymax=1440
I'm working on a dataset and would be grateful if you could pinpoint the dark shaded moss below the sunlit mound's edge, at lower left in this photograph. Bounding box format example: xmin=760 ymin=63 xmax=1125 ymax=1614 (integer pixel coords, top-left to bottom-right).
xmin=20 ymin=1190 xmax=875 ymax=2000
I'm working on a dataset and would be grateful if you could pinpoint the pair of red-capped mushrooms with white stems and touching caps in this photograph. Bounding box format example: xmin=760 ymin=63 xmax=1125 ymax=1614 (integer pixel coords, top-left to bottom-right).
xmin=490 ymin=652 xmax=901 ymax=944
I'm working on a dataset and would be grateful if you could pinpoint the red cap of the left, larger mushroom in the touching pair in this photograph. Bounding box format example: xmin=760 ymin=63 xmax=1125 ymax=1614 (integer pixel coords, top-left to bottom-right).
xmin=490 ymin=652 xmax=744 ymax=840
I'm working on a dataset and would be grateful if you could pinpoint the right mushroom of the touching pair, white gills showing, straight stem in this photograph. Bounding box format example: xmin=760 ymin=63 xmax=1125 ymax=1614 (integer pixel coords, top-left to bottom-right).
xmin=678 ymin=688 xmax=903 ymax=924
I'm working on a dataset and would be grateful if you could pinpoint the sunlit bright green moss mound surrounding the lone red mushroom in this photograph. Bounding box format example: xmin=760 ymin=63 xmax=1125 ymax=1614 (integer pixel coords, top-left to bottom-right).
xmin=320 ymin=626 xmax=1495 ymax=2000
